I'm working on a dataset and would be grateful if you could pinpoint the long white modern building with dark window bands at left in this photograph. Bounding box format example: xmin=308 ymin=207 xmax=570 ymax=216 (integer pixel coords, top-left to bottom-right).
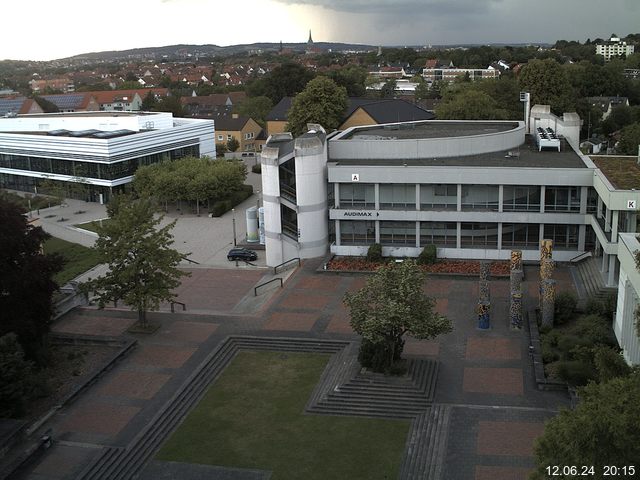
xmin=0 ymin=112 xmax=215 ymax=201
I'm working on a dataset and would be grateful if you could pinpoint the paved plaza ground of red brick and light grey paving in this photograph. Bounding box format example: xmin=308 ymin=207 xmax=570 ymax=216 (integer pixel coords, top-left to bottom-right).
xmin=7 ymin=177 xmax=576 ymax=480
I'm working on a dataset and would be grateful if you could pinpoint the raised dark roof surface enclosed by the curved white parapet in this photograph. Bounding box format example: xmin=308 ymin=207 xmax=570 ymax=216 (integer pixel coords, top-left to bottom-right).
xmin=337 ymin=120 xmax=519 ymax=141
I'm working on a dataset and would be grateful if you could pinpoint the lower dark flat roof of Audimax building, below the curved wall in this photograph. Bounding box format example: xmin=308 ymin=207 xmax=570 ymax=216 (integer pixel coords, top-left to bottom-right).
xmin=329 ymin=136 xmax=588 ymax=168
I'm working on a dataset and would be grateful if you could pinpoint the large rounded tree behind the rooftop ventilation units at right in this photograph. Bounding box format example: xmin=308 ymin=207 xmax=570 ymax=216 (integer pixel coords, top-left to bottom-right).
xmin=519 ymin=59 xmax=574 ymax=115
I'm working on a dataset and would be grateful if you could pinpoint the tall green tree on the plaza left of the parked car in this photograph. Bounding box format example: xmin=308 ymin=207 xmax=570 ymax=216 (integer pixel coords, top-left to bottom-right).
xmin=86 ymin=196 xmax=188 ymax=328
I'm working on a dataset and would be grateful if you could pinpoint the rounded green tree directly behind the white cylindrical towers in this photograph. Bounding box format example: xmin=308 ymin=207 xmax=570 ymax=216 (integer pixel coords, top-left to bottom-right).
xmin=287 ymin=76 xmax=348 ymax=135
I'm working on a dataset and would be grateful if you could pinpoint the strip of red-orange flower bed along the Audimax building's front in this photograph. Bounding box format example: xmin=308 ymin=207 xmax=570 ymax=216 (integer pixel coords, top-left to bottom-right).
xmin=327 ymin=257 xmax=509 ymax=276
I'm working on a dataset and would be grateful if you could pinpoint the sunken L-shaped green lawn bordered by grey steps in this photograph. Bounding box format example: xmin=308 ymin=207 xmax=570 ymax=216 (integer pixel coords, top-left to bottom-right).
xmin=157 ymin=351 xmax=410 ymax=480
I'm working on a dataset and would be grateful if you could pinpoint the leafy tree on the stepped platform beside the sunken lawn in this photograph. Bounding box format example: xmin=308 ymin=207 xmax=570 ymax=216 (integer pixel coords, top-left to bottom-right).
xmin=343 ymin=260 xmax=452 ymax=371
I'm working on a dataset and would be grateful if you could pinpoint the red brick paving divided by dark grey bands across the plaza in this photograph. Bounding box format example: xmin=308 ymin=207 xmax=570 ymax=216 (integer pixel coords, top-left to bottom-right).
xmin=21 ymin=260 xmax=573 ymax=480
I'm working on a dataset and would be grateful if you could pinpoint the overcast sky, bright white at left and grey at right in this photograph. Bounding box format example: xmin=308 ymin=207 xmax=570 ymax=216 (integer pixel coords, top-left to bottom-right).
xmin=0 ymin=0 xmax=640 ymax=60
